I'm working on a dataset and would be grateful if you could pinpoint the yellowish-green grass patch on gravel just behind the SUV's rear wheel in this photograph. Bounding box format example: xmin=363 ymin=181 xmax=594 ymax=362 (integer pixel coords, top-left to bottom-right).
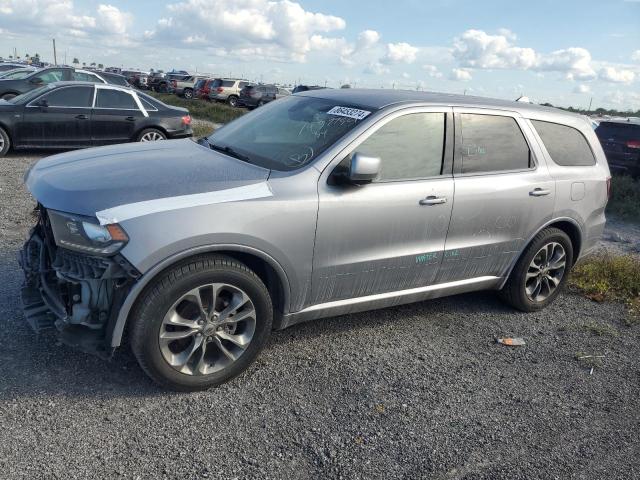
xmin=569 ymin=254 xmax=640 ymax=324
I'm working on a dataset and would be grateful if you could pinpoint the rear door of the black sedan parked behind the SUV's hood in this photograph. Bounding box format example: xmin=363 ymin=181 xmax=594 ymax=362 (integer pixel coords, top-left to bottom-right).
xmin=92 ymin=85 xmax=146 ymax=145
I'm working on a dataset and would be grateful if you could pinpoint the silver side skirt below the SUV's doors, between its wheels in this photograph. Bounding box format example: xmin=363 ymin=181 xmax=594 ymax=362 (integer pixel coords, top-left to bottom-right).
xmin=281 ymin=276 xmax=503 ymax=329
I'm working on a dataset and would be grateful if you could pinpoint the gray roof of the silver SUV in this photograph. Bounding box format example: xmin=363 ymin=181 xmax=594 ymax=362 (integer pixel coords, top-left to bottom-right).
xmin=296 ymin=88 xmax=575 ymax=116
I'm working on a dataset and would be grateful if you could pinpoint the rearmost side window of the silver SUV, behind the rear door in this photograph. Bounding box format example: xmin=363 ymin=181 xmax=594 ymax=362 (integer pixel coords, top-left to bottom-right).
xmin=531 ymin=120 xmax=596 ymax=167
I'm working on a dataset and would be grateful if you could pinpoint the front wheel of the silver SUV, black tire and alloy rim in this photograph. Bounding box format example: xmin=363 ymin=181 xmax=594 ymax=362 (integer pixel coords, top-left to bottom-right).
xmin=130 ymin=255 xmax=273 ymax=391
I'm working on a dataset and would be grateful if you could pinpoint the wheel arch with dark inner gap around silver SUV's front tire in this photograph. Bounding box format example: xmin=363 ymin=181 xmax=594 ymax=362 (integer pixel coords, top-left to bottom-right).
xmin=106 ymin=245 xmax=290 ymax=348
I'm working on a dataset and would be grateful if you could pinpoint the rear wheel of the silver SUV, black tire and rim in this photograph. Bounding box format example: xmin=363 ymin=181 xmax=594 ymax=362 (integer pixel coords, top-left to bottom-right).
xmin=499 ymin=228 xmax=573 ymax=312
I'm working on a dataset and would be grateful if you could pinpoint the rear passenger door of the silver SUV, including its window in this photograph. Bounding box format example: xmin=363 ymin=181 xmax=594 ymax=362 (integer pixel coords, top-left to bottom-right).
xmin=438 ymin=108 xmax=555 ymax=283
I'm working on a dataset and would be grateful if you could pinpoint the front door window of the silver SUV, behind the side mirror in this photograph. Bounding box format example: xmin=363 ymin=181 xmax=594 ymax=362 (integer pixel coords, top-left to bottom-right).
xmin=355 ymin=113 xmax=445 ymax=181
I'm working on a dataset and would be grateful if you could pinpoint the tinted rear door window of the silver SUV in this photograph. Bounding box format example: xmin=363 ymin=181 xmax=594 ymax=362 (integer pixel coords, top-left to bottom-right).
xmin=458 ymin=113 xmax=531 ymax=173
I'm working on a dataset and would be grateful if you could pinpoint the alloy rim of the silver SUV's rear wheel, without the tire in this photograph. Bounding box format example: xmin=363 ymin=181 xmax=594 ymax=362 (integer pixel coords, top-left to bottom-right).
xmin=525 ymin=242 xmax=567 ymax=302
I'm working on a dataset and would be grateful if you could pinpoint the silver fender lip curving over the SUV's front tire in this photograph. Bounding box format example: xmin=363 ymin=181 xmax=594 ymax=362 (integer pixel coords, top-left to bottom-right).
xmin=105 ymin=244 xmax=291 ymax=349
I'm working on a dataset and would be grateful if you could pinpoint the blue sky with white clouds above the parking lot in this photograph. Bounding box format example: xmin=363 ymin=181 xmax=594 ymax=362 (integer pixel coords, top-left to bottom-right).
xmin=0 ymin=0 xmax=640 ymax=110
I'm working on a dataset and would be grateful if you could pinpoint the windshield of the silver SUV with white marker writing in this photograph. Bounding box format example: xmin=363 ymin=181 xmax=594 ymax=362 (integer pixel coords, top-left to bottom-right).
xmin=207 ymin=96 xmax=374 ymax=171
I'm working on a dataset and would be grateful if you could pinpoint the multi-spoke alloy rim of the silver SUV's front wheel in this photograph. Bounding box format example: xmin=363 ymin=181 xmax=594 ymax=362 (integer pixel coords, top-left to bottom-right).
xmin=158 ymin=283 xmax=256 ymax=375
